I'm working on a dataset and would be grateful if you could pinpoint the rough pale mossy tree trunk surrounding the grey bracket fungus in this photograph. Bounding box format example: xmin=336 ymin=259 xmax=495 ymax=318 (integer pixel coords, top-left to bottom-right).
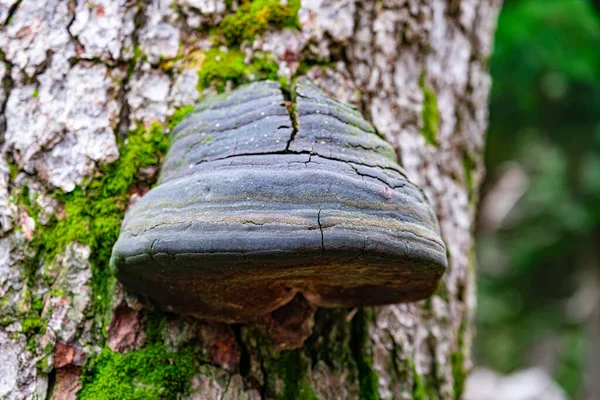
xmin=0 ymin=0 xmax=500 ymax=399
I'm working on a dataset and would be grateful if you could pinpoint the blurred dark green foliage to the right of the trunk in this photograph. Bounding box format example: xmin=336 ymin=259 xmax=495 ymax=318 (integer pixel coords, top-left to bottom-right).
xmin=475 ymin=0 xmax=600 ymax=399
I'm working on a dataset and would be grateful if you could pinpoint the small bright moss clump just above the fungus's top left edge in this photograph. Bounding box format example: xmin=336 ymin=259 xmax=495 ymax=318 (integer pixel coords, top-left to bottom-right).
xmin=198 ymin=48 xmax=279 ymax=92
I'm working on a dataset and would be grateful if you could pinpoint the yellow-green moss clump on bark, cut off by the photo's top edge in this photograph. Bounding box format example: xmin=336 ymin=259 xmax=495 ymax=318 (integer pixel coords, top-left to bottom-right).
xmin=218 ymin=0 xmax=300 ymax=46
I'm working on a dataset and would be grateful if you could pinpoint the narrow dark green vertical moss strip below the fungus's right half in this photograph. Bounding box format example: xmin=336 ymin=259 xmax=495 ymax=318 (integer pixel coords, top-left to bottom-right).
xmin=352 ymin=308 xmax=380 ymax=400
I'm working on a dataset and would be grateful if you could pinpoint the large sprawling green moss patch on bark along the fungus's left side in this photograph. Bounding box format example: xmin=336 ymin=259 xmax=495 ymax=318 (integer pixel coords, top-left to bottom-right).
xmin=20 ymin=107 xmax=192 ymax=334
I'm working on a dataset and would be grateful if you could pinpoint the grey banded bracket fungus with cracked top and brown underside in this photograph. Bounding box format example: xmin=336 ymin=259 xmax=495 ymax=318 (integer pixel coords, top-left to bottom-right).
xmin=111 ymin=79 xmax=447 ymax=322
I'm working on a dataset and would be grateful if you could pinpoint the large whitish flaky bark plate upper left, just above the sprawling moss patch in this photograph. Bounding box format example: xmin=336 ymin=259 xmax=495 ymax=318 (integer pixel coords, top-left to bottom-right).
xmin=5 ymin=62 xmax=118 ymax=191
